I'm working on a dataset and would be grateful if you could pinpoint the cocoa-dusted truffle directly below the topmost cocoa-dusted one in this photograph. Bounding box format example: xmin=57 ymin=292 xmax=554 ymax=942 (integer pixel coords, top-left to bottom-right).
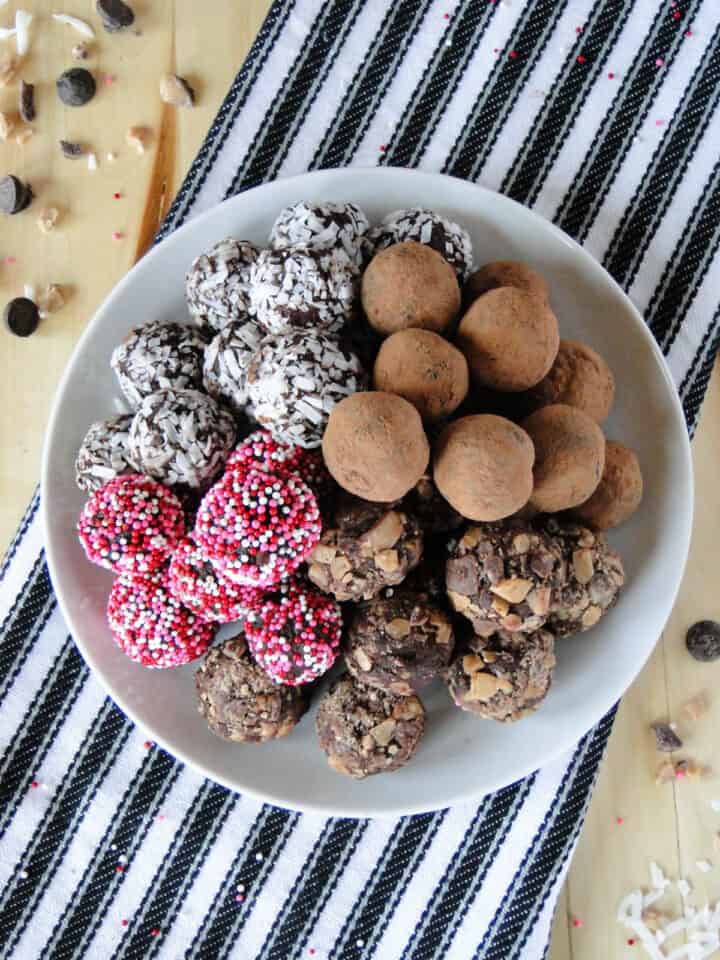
xmin=373 ymin=329 xmax=470 ymax=421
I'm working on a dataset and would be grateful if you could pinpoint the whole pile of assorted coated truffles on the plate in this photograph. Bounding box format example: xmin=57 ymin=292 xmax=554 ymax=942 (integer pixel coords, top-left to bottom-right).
xmin=76 ymin=201 xmax=642 ymax=778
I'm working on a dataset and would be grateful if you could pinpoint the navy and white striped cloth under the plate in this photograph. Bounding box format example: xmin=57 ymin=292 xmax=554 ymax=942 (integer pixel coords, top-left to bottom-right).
xmin=0 ymin=0 xmax=720 ymax=960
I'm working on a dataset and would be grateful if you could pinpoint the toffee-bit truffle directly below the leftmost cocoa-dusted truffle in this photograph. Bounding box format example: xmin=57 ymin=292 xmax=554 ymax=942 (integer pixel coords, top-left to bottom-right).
xmin=307 ymin=501 xmax=423 ymax=601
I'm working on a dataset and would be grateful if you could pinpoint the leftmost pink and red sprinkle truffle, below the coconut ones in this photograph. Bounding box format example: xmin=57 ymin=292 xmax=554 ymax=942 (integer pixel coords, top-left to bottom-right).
xmin=78 ymin=474 xmax=185 ymax=574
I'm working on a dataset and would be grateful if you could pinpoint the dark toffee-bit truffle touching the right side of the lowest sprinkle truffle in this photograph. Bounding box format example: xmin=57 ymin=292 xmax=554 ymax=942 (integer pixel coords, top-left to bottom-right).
xmin=345 ymin=589 xmax=454 ymax=696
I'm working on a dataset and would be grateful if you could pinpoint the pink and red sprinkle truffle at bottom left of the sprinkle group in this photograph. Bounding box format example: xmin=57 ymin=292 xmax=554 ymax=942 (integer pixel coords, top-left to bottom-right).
xmin=107 ymin=570 xmax=215 ymax=668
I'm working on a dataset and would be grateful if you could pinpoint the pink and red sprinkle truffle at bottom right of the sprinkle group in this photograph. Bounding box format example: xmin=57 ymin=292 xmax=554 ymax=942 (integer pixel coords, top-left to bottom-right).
xmin=245 ymin=584 xmax=342 ymax=687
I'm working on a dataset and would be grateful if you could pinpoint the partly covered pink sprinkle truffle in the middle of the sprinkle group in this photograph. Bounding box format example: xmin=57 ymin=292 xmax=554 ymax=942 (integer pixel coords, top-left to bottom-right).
xmin=168 ymin=537 xmax=264 ymax=623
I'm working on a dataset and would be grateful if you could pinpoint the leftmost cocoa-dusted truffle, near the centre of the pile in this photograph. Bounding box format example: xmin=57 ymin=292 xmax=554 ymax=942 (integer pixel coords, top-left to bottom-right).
xmin=322 ymin=391 xmax=430 ymax=503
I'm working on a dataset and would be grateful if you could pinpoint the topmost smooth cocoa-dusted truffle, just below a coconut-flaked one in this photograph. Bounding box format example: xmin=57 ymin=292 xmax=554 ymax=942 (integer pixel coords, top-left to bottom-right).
xmin=362 ymin=240 xmax=460 ymax=336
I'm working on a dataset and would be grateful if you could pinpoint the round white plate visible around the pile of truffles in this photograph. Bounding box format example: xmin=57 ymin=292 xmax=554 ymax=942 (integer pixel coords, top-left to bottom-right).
xmin=42 ymin=168 xmax=692 ymax=816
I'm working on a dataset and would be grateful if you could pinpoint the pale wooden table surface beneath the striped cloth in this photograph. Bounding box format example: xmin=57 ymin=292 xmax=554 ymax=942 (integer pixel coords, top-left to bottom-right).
xmin=0 ymin=0 xmax=720 ymax=960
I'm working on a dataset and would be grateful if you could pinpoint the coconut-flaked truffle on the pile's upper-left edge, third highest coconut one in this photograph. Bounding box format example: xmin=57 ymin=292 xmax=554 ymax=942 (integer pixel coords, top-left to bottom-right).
xmin=185 ymin=237 xmax=258 ymax=331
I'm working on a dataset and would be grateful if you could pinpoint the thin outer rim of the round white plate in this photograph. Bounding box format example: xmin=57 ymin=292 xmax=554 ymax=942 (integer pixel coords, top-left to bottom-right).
xmin=40 ymin=166 xmax=695 ymax=818
